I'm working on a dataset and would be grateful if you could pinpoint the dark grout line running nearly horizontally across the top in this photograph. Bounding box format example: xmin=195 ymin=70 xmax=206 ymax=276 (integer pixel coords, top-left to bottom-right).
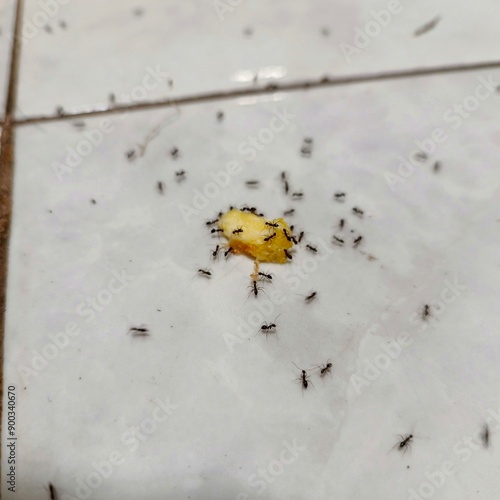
xmin=7 ymin=61 xmax=500 ymax=126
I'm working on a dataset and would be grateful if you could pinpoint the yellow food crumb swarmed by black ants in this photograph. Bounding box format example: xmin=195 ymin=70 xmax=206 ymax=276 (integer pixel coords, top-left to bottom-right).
xmin=219 ymin=209 xmax=293 ymax=264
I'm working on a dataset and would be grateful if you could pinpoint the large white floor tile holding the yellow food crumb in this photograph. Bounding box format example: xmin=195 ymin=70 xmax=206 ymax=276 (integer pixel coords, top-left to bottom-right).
xmin=3 ymin=67 xmax=500 ymax=500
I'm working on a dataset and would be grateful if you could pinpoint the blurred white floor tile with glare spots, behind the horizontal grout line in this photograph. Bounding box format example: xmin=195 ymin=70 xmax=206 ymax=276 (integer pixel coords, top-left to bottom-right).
xmin=18 ymin=0 xmax=500 ymax=117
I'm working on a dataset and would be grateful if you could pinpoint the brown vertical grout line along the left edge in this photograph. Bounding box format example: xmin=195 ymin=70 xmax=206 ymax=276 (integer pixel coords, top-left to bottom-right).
xmin=0 ymin=0 xmax=23 ymax=470
